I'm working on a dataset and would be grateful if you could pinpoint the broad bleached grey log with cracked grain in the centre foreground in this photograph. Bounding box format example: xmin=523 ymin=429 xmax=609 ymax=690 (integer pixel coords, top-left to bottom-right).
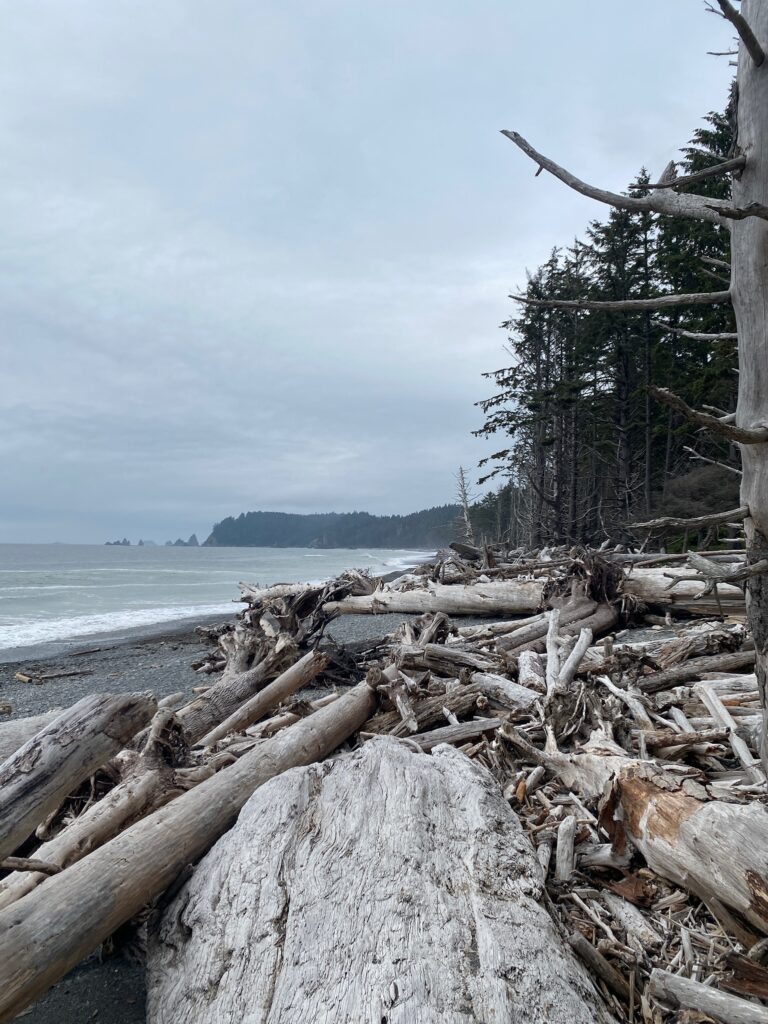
xmin=147 ymin=738 xmax=610 ymax=1024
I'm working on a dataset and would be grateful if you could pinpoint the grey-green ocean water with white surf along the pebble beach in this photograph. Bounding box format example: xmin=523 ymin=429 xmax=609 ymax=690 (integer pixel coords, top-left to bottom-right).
xmin=0 ymin=544 xmax=433 ymax=650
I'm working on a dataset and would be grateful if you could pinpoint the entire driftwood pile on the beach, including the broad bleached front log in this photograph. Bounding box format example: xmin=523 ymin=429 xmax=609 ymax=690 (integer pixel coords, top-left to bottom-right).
xmin=0 ymin=545 xmax=768 ymax=1024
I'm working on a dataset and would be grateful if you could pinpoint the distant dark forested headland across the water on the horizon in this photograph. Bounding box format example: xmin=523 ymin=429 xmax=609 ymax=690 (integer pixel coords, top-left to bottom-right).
xmin=204 ymin=505 xmax=459 ymax=550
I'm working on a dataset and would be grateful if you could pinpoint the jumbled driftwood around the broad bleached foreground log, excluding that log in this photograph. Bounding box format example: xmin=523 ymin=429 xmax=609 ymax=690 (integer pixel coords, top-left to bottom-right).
xmin=0 ymin=545 xmax=768 ymax=1024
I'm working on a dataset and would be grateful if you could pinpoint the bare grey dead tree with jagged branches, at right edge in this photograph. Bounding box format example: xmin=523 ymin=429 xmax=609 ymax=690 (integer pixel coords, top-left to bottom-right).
xmin=503 ymin=0 xmax=768 ymax=767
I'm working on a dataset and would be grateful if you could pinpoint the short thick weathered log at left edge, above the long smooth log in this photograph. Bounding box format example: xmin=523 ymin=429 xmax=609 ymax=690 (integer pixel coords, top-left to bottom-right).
xmin=0 ymin=693 xmax=157 ymax=860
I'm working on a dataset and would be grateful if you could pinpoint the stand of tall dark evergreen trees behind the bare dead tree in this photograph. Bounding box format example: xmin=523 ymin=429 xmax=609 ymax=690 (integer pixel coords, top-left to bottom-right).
xmin=474 ymin=101 xmax=740 ymax=545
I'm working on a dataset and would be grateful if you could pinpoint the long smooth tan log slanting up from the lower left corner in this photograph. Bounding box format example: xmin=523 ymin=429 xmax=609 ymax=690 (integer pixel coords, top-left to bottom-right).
xmin=0 ymin=683 xmax=376 ymax=1021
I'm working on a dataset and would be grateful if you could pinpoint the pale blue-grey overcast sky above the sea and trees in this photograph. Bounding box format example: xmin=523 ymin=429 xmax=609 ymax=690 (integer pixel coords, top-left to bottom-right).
xmin=0 ymin=0 xmax=731 ymax=542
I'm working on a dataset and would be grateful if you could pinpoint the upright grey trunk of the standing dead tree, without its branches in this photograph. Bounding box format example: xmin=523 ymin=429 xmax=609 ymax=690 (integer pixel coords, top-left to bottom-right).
xmin=731 ymin=0 xmax=768 ymax=766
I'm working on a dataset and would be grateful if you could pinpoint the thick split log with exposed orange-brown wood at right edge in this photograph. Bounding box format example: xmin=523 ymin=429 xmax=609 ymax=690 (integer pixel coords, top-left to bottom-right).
xmin=613 ymin=762 xmax=768 ymax=934
